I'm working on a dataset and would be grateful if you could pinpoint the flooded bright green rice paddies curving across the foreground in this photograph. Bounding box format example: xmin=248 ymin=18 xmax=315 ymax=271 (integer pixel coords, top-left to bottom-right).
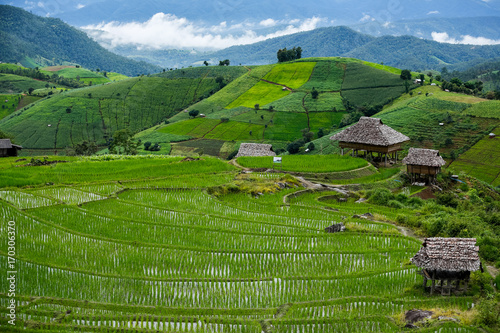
xmin=0 ymin=157 xmax=488 ymax=333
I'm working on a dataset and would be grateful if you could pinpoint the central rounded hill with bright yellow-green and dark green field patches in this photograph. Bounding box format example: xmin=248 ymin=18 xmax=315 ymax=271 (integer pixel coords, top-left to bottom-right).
xmin=155 ymin=58 xmax=410 ymax=156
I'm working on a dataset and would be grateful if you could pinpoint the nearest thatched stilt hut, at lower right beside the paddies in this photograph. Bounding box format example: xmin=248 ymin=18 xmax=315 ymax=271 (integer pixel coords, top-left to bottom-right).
xmin=411 ymin=237 xmax=483 ymax=295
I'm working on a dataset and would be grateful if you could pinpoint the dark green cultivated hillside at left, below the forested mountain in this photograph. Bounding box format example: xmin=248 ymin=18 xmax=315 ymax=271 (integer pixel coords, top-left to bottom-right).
xmin=0 ymin=69 xmax=248 ymax=150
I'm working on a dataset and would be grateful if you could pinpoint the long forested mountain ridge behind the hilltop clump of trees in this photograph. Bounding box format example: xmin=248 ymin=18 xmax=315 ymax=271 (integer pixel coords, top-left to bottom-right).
xmin=126 ymin=26 xmax=500 ymax=70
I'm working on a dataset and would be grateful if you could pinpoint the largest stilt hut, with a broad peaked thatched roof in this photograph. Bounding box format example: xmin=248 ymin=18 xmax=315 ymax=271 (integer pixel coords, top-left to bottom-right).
xmin=330 ymin=117 xmax=410 ymax=164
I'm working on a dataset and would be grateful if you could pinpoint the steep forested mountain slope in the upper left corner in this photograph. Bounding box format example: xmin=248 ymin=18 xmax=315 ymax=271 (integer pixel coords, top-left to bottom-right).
xmin=0 ymin=5 xmax=160 ymax=76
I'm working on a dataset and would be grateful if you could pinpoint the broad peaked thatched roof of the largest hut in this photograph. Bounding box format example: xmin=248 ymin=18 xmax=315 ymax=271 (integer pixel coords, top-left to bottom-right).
xmin=330 ymin=117 xmax=410 ymax=146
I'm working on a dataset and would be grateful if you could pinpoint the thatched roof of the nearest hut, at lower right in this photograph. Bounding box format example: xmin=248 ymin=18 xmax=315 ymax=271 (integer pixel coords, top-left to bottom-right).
xmin=411 ymin=237 xmax=481 ymax=272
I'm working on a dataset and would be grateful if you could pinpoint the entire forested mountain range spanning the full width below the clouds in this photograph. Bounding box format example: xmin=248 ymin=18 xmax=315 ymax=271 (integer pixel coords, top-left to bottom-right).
xmin=0 ymin=6 xmax=500 ymax=76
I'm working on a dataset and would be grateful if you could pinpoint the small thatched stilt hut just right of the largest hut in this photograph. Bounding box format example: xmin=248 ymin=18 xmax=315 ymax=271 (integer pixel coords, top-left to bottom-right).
xmin=403 ymin=148 xmax=446 ymax=182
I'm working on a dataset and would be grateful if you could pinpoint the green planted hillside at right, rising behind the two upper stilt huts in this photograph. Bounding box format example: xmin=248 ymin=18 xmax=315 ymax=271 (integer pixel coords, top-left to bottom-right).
xmin=376 ymin=86 xmax=500 ymax=158
